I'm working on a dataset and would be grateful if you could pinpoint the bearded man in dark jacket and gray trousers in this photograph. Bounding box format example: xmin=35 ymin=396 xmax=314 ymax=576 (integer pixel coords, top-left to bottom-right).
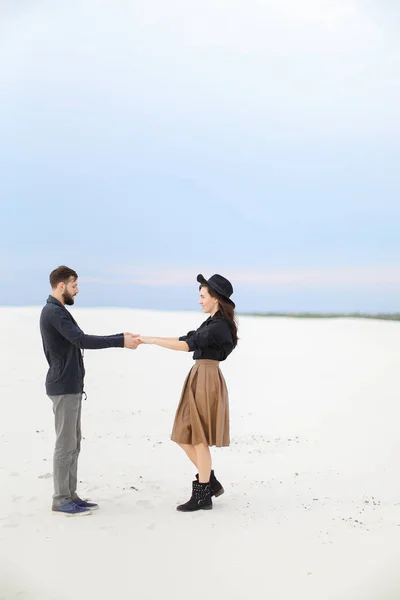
xmin=40 ymin=266 xmax=140 ymax=516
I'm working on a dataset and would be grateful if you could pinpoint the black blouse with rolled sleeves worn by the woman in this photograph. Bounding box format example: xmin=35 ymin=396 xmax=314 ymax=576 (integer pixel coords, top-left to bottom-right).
xmin=179 ymin=313 xmax=233 ymax=361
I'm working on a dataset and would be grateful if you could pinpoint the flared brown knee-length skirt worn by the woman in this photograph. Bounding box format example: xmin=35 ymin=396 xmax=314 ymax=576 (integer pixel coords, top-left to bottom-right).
xmin=171 ymin=359 xmax=230 ymax=447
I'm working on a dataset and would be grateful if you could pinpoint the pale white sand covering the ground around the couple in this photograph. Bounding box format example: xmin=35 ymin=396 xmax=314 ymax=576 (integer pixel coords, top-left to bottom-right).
xmin=0 ymin=308 xmax=400 ymax=600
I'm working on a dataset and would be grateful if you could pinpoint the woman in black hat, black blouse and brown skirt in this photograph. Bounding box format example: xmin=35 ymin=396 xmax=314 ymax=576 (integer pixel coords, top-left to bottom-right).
xmin=139 ymin=275 xmax=238 ymax=512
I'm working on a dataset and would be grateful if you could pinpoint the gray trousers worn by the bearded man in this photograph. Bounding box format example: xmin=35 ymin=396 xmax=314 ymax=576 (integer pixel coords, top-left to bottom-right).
xmin=49 ymin=394 xmax=82 ymax=506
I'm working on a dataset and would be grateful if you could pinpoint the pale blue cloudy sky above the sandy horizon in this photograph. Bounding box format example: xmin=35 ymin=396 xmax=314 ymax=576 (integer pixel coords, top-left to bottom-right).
xmin=0 ymin=0 xmax=400 ymax=312
